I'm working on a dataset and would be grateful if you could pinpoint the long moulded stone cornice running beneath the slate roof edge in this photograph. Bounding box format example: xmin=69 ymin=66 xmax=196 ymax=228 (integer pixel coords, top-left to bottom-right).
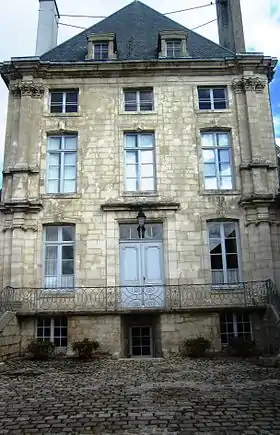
xmin=0 ymin=54 xmax=277 ymax=86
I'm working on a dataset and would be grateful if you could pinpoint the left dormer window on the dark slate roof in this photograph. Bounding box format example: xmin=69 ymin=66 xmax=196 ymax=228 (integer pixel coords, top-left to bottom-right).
xmin=86 ymin=33 xmax=117 ymax=61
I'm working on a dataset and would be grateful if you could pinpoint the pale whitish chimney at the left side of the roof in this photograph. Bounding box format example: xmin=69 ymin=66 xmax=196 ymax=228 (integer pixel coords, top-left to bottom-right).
xmin=36 ymin=0 xmax=60 ymax=56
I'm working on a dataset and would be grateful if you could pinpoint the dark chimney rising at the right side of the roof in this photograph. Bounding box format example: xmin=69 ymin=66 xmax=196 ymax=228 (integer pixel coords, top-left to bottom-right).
xmin=216 ymin=0 xmax=245 ymax=53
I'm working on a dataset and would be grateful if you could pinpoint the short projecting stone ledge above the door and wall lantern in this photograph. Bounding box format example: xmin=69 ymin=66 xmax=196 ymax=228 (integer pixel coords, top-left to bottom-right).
xmin=101 ymin=201 xmax=180 ymax=212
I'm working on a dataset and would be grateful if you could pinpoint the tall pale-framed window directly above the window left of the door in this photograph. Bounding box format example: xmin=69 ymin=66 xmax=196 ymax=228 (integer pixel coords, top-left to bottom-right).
xmin=46 ymin=135 xmax=77 ymax=193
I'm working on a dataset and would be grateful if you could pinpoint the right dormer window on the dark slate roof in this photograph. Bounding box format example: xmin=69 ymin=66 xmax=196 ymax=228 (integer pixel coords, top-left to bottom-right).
xmin=159 ymin=30 xmax=188 ymax=59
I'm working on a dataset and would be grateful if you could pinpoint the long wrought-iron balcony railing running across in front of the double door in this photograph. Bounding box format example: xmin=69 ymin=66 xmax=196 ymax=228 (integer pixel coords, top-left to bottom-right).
xmin=0 ymin=281 xmax=275 ymax=315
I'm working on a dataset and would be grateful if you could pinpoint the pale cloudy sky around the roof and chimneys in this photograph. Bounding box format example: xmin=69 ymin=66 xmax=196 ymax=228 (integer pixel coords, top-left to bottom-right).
xmin=0 ymin=0 xmax=280 ymax=180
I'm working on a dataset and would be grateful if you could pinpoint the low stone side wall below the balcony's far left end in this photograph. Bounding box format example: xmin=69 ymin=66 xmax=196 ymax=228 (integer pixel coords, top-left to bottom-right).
xmin=0 ymin=311 xmax=21 ymax=361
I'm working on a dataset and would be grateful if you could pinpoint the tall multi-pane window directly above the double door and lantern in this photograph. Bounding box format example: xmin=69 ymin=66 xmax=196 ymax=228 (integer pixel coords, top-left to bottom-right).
xmin=124 ymin=133 xmax=155 ymax=192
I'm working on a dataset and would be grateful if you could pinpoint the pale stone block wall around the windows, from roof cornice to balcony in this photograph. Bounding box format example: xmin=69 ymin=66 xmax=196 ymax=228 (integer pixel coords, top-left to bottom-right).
xmin=0 ymin=70 xmax=280 ymax=288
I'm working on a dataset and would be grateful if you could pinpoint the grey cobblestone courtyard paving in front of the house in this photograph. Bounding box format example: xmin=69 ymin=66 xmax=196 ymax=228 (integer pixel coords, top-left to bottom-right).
xmin=0 ymin=359 xmax=280 ymax=435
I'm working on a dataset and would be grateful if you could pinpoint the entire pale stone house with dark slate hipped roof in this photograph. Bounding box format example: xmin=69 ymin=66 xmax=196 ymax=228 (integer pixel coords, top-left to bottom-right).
xmin=0 ymin=1 xmax=280 ymax=356
